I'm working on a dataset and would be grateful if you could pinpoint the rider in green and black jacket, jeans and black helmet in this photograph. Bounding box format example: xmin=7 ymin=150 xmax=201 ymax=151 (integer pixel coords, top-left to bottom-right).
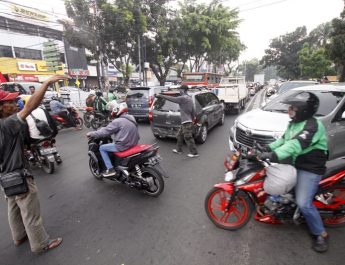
xmin=259 ymin=92 xmax=328 ymax=252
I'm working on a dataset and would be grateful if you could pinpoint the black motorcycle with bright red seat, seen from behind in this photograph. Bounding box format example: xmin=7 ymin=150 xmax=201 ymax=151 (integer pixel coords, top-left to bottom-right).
xmin=88 ymin=138 xmax=167 ymax=197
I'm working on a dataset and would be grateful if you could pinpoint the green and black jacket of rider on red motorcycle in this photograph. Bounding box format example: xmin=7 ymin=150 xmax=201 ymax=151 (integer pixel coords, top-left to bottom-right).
xmin=269 ymin=118 xmax=328 ymax=175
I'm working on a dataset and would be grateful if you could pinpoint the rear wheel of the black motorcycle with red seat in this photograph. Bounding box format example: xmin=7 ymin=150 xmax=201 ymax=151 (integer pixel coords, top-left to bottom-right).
xmin=142 ymin=167 xmax=164 ymax=197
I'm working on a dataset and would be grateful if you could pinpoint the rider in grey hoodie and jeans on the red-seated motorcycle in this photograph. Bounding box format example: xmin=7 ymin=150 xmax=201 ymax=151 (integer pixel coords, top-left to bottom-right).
xmin=87 ymin=101 xmax=140 ymax=178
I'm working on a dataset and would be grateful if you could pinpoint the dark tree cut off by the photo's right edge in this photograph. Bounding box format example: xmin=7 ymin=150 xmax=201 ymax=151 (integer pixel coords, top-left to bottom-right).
xmin=327 ymin=9 xmax=345 ymax=82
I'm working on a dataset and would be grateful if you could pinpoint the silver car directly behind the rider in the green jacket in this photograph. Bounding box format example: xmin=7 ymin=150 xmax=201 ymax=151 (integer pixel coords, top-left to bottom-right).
xmin=229 ymin=84 xmax=345 ymax=159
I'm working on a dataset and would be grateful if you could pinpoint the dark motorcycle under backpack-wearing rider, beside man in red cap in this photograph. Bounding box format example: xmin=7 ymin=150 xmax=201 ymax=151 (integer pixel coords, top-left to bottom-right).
xmin=25 ymin=138 xmax=62 ymax=174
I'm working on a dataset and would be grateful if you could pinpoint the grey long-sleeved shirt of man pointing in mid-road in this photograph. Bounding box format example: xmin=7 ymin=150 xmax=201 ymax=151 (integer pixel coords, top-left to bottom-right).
xmin=161 ymin=94 xmax=195 ymax=124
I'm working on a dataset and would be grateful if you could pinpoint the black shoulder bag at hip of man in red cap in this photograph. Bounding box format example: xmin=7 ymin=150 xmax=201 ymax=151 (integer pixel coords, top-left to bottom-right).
xmin=0 ymin=170 xmax=29 ymax=197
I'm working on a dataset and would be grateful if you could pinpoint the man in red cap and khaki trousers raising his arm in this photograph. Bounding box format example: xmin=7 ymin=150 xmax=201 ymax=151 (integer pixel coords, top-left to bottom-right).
xmin=0 ymin=75 xmax=66 ymax=253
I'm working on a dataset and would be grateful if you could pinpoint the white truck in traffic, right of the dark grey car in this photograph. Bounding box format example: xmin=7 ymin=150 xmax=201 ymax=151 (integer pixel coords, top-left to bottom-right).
xmin=213 ymin=76 xmax=250 ymax=113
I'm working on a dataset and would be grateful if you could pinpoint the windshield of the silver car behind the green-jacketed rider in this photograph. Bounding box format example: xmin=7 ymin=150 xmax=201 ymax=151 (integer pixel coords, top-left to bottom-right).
xmin=262 ymin=91 xmax=345 ymax=116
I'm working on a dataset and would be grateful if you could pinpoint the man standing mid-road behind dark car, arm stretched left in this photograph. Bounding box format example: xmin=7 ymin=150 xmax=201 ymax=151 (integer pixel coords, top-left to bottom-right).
xmin=156 ymin=85 xmax=199 ymax=157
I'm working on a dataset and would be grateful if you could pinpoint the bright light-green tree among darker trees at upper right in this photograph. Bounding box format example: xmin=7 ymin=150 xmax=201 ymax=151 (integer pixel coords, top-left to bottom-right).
xmin=298 ymin=43 xmax=334 ymax=79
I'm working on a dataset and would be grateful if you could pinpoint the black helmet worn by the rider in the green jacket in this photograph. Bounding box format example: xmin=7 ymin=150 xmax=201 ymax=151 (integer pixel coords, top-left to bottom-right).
xmin=281 ymin=92 xmax=320 ymax=122
